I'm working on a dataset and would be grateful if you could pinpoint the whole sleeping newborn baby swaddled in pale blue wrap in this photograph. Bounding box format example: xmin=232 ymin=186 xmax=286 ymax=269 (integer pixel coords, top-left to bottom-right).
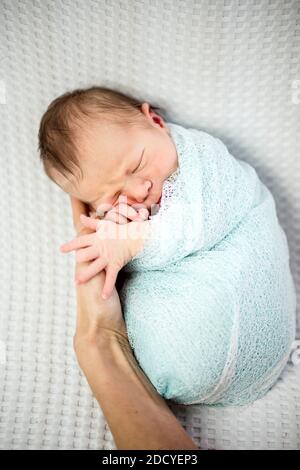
xmin=39 ymin=87 xmax=296 ymax=406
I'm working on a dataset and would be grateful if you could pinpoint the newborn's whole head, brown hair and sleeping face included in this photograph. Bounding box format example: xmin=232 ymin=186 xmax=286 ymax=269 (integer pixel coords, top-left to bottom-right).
xmin=39 ymin=87 xmax=178 ymax=214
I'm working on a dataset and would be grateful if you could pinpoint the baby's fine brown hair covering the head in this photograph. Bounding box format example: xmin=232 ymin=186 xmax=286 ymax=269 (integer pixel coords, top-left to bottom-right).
xmin=38 ymin=86 xmax=164 ymax=182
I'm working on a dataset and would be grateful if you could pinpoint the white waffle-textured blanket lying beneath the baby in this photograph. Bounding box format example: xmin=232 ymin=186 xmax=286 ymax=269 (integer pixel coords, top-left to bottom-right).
xmin=0 ymin=0 xmax=300 ymax=449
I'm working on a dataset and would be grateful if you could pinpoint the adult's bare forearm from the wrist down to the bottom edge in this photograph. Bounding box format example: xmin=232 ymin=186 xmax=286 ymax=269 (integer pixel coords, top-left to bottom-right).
xmin=76 ymin=333 xmax=198 ymax=450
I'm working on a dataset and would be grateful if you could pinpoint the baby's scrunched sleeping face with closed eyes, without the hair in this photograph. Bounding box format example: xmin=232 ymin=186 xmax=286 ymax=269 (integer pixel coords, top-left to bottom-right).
xmin=53 ymin=103 xmax=178 ymax=214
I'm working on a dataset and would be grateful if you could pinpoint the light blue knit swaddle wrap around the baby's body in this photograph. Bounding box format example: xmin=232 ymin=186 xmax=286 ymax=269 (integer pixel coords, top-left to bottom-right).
xmin=120 ymin=123 xmax=296 ymax=405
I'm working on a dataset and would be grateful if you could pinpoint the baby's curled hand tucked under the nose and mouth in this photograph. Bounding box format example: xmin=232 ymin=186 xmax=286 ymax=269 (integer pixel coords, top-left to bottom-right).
xmin=90 ymin=195 xmax=149 ymax=224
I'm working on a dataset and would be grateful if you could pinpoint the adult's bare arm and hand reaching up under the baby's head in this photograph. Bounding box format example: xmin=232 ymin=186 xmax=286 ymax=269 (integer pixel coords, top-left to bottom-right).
xmin=64 ymin=197 xmax=198 ymax=450
